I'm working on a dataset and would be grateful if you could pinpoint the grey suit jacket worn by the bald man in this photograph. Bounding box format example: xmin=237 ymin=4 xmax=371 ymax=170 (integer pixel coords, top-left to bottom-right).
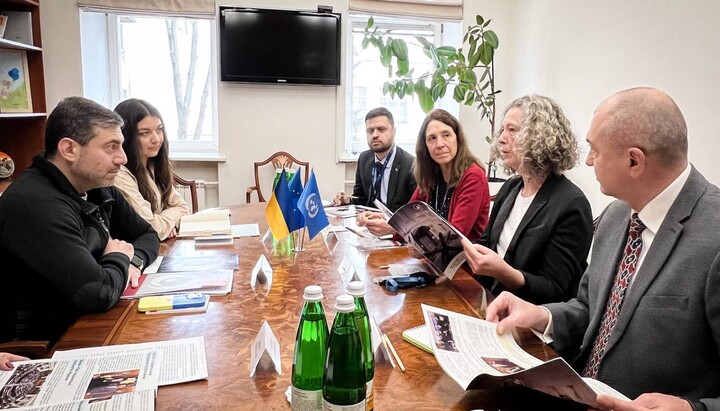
xmin=546 ymin=168 xmax=720 ymax=411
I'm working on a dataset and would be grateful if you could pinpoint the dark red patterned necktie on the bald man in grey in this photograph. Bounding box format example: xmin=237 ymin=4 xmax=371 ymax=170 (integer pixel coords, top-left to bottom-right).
xmin=583 ymin=213 xmax=645 ymax=378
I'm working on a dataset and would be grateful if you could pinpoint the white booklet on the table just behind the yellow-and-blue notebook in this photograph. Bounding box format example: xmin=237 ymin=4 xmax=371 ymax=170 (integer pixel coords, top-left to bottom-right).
xmin=120 ymin=270 xmax=233 ymax=299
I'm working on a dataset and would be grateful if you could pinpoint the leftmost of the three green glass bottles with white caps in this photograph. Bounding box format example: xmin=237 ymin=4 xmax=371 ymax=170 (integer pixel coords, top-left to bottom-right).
xmin=292 ymin=285 xmax=328 ymax=411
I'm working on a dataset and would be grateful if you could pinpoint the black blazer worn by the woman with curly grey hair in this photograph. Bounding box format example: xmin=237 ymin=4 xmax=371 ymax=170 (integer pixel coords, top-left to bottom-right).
xmin=478 ymin=175 xmax=592 ymax=304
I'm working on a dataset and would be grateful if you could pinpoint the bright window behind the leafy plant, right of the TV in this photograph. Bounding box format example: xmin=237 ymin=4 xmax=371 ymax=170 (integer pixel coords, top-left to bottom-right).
xmin=345 ymin=15 xmax=461 ymax=155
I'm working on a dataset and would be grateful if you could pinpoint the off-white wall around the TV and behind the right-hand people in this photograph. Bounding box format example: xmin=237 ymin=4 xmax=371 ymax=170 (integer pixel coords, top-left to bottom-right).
xmin=41 ymin=0 xmax=720 ymax=214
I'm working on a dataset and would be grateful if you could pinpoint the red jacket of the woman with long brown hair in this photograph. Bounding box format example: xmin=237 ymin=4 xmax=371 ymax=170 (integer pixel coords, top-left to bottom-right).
xmin=410 ymin=164 xmax=490 ymax=242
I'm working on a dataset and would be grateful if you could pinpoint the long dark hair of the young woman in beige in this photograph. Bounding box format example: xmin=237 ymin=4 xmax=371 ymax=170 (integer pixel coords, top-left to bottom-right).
xmin=115 ymin=98 xmax=173 ymax=213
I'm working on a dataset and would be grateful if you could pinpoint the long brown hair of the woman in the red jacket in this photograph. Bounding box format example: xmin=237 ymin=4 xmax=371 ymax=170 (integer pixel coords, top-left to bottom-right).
xmin=413 ymin=109 xmax=485 ymax=194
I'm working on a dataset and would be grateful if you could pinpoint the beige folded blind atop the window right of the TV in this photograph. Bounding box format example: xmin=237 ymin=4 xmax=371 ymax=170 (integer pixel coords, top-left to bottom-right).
xmin=348 ymin=0 xmax=463 ymax=20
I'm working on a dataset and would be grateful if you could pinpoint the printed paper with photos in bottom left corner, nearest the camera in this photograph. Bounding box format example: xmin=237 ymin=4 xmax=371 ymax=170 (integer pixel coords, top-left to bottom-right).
xmin=0 ymin=350 xmax=162 ymax=408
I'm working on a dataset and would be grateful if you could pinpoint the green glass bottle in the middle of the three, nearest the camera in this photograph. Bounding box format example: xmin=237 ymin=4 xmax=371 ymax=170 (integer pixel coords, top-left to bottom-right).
xmin=323 ymin=295 xmax=365 ymax=411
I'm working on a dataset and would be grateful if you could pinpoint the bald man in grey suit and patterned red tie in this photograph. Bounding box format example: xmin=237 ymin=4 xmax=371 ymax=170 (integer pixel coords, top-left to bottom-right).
xmin=487 ymin=88 xmax=720 ymax=411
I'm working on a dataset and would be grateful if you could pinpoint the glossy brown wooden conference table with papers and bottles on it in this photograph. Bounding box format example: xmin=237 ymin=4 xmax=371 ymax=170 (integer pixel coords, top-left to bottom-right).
xmin=54 ymin=203 xmax=583 ymax=410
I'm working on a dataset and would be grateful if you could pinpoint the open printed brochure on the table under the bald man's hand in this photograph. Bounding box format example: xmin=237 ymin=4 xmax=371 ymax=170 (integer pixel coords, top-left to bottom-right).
xmin=422 ymin=304 xmax=629 ymax=409
